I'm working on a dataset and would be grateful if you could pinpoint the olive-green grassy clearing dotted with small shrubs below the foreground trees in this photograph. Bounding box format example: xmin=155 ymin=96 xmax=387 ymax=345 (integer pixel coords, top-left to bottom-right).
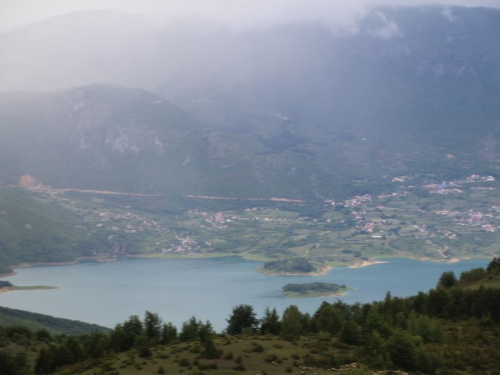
xmin=69 ymin=336 xmax=372 ymax=375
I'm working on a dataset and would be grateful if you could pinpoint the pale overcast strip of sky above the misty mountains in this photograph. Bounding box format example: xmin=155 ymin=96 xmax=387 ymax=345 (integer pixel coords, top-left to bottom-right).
xmin=0 ymin=0 xmax=500 ymax=32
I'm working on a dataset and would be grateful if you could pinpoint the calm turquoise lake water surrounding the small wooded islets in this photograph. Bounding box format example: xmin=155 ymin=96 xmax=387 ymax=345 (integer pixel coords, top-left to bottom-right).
xmin=0 ymin=257 xmax=488 ymax=330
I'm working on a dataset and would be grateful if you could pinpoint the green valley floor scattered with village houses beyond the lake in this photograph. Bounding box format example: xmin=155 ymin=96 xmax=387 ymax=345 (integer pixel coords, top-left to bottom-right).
xmin=8 ymin=175 xmax=500 ymax=274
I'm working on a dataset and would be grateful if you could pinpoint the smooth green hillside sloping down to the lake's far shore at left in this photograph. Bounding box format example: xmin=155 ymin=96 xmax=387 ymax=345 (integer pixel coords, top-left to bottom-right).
xmin=0 ymin=187 xmax=109 ymax=274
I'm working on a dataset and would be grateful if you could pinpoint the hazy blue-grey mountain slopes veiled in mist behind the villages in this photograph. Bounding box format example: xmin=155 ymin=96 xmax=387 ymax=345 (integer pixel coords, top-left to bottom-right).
xmin=0 ymin=6 xmax=500 ymax=199
